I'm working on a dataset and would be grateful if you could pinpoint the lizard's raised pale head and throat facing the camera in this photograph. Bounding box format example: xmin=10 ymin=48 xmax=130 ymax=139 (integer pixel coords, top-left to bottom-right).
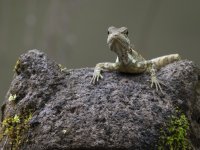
xmin=107 ymin=26 xmax=130 ymax=64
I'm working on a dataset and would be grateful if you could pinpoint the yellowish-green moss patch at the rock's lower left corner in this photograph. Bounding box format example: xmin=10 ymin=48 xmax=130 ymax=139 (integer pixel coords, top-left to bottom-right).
xmin=0 ymin=113 xmax=32 ymax=150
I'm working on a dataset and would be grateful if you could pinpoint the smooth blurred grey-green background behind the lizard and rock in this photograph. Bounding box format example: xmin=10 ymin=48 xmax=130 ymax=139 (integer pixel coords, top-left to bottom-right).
xmin=0 ymin=0 xmax=200 ymax=103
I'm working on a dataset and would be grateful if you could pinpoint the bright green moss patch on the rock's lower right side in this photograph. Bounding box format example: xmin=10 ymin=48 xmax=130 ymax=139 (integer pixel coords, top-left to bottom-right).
xmin=158 ymin=111 xmax=191 ymax=150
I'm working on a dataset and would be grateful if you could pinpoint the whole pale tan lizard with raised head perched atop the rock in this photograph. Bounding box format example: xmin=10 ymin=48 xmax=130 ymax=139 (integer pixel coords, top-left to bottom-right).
xmin=91 ymin=26 xmax=181 ymax=93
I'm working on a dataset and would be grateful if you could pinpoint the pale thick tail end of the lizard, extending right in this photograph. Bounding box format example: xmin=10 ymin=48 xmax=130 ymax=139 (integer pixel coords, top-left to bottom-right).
xmin=150 ymin=54 xmax=181 ymax=69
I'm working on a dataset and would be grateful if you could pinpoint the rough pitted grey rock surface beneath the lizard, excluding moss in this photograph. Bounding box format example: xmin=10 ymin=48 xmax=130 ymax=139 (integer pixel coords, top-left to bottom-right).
xmin=0 ymin=50 xmax=200 ymax=150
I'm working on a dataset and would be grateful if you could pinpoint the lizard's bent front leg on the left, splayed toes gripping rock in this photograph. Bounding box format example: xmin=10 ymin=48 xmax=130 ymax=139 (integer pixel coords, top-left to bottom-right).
xmin=91 ymin=62 xmax=119 ymax=84
